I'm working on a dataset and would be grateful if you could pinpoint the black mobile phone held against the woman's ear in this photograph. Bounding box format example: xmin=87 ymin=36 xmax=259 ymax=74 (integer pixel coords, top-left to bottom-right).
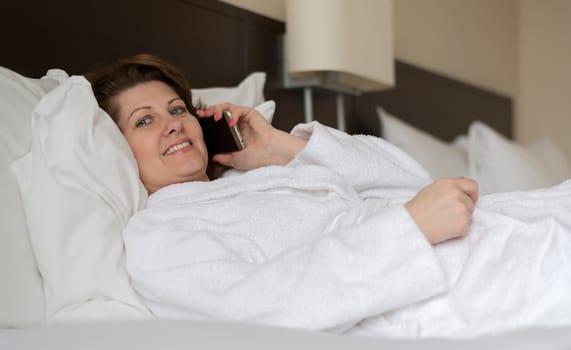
xmin=198 ymin=111 xmax=246 ymax=158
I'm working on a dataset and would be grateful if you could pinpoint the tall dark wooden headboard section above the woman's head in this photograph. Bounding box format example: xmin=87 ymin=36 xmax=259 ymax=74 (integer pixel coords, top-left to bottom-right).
xmin=0 ymin=0 xmax=285 ymax=87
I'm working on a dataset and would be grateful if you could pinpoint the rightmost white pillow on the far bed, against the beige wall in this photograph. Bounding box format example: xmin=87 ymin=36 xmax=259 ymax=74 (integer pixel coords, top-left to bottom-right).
xmin=468 ymin=121 xmax=569 ymax=194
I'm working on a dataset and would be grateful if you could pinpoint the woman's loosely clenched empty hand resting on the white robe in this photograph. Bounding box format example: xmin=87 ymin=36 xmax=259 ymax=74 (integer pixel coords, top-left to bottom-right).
xmin=405 ymin=178 xmax=478 ymax=244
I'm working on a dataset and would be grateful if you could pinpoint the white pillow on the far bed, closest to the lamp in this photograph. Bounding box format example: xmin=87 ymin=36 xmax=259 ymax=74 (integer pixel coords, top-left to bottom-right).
xmin=377 ymin=107 xmax=468 ymax=180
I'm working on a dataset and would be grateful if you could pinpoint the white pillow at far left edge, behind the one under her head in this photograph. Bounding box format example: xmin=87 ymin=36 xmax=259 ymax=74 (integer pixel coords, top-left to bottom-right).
xmin=0 ymin=67 xmax=66 ymax=328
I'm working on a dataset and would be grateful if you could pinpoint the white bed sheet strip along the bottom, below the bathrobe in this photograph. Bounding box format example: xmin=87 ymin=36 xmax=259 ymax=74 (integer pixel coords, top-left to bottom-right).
xmin=0 ymin=321 xmax=571 ymax=350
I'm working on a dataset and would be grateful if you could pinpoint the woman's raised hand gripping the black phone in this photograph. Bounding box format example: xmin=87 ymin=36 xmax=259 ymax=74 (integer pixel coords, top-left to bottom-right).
xmin=197 ymin=103 xmax=307 ymax=170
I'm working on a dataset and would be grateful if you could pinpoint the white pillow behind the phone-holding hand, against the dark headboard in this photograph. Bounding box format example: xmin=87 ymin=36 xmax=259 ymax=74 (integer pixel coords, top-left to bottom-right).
xmin=191 ymin=72 xmax=266 ymax=107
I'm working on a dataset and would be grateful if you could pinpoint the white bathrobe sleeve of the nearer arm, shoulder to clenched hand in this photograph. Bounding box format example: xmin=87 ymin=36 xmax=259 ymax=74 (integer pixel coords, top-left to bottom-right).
xmin=125 ymin=201 xmax=446 ymax=330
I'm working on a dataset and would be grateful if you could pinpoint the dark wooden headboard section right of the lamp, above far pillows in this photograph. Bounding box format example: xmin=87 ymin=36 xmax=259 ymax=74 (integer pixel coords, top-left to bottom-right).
xmin=353 ymin=61 xmax=513 ymax=141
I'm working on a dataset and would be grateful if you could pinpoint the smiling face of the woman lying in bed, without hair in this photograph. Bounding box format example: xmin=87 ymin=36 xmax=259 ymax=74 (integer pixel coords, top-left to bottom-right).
xmin=115 ymin=81 xmax=208 ymax=193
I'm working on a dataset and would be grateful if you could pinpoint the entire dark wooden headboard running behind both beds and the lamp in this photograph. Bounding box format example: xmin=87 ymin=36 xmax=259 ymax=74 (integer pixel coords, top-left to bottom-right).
xmin=0 ymin=0 xmax=512 ymax=140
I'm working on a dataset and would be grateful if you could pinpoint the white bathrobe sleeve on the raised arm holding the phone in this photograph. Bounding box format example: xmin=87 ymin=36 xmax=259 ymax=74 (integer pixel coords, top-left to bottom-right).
xmin=288 ymin=122 xmax=432 ymax=198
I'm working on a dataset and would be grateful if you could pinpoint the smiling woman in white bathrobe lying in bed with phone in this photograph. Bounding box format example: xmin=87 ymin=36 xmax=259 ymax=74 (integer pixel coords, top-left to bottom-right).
xmin=90 ymin=55 xmax=571 ymax=335
